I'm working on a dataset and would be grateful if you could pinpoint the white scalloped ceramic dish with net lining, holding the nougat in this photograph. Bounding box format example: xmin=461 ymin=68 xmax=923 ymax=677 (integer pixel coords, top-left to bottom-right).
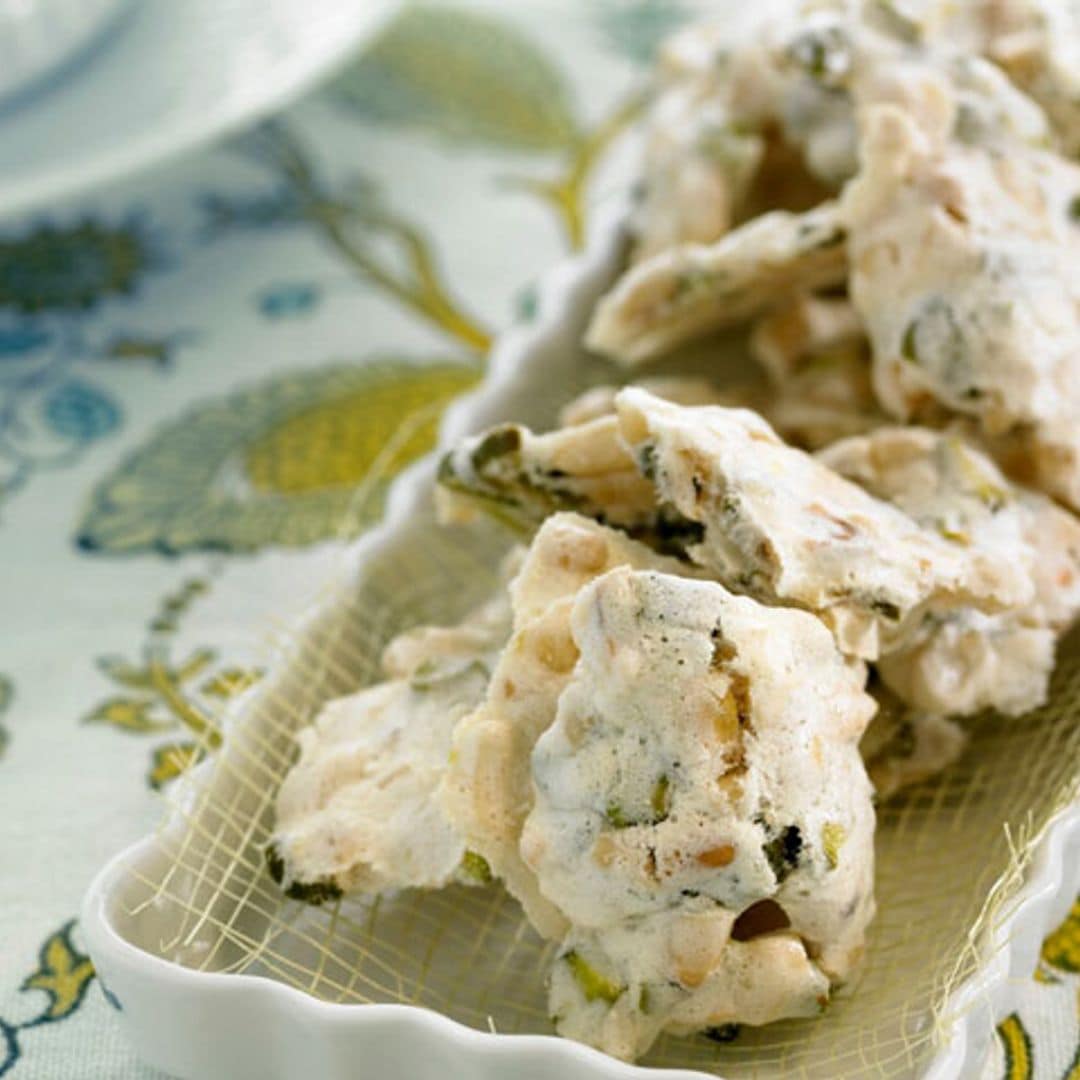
xmin=82 ymin=204 xmax=1080 ymax=1080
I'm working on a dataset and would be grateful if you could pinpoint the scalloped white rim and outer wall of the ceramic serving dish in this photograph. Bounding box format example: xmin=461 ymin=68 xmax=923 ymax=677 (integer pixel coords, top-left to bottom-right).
xmin=82 ymin=204 xmax=1080 ymax=1080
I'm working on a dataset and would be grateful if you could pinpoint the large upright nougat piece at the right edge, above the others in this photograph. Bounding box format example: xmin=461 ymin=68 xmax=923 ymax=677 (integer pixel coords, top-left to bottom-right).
xmin=843 ymin=108 xmax=1080 ymax=497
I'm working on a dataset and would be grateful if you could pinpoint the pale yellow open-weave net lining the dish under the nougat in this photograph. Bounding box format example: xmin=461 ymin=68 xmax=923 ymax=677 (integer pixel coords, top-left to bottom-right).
xmin=116 ymin=324 xmax=1080 ymax=1080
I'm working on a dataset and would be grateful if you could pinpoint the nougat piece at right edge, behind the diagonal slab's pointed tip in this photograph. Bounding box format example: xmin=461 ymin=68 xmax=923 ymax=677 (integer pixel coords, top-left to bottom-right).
xmin=820 ymin=428 xmax=1080 ymax=715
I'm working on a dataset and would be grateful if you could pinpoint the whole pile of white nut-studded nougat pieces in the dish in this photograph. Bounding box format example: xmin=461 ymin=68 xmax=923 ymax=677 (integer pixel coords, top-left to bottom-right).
xmin=268 ymin=0 xmax=1080 ymax=1059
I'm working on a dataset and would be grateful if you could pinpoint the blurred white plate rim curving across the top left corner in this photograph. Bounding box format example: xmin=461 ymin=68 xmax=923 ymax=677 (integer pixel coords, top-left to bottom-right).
xmin=0 ymin=0 xmax=397 ymax=216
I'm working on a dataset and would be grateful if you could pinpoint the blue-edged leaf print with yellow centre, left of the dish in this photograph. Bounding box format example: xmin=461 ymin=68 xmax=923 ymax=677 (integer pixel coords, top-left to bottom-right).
xmin=78 ymin=357 xmax=480 ymax=552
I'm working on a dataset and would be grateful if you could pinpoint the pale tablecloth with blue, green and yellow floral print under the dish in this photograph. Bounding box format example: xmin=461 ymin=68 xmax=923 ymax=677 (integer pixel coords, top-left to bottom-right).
xmin=0 ymin=0 xmax=1080 ymax=1080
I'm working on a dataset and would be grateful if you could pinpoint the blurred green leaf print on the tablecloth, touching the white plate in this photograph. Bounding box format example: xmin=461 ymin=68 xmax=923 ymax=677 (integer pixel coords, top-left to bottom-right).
xmin=328 ymin=4 xmax=578 ymax=151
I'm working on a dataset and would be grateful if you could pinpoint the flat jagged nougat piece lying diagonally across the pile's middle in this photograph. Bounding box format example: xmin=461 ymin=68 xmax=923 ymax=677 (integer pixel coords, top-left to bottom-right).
xmin=617 ymin=389 xmax=1032 ymax=660
